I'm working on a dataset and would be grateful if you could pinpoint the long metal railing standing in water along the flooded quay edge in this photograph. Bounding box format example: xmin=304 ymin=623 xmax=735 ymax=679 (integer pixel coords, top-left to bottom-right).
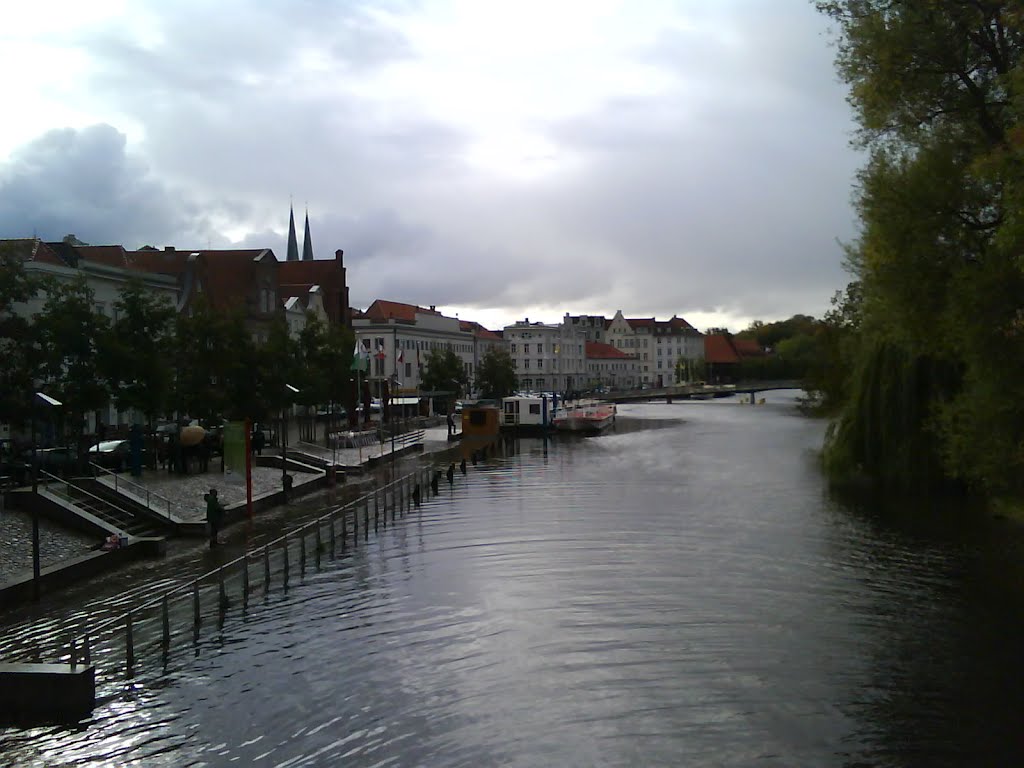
xmin=58 ymin=467 xmax=436 ymax=678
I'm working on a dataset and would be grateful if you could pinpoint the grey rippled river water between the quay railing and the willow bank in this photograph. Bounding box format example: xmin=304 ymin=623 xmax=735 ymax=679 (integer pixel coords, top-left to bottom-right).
xmin=0 ymin=393 xmax=1024 ymax=767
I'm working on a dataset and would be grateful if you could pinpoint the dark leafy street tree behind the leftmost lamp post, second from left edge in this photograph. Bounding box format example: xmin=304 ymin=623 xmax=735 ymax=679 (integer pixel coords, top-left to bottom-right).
xmin=35 ymin=276 xmax=110 ymax=454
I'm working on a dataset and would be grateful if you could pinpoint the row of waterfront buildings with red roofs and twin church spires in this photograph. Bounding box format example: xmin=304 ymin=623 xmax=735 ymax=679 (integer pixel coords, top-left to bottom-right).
xmin=8 ymin=209 xmax=720 ymax=409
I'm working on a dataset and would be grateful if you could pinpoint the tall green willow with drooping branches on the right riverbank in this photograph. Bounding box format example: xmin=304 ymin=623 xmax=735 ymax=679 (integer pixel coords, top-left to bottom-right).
xmin=817 ymin=0 xmax=1024 ymax=493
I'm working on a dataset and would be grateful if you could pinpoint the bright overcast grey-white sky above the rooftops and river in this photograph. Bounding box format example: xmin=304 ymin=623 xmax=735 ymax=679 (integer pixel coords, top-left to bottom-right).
xmin=0 ymin=0 xmax=861 ymax=331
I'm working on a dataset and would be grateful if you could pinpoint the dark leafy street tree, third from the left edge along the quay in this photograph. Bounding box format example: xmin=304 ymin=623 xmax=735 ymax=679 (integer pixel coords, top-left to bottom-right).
xmin=103 ymin=279 xmax=176 ymax=429
